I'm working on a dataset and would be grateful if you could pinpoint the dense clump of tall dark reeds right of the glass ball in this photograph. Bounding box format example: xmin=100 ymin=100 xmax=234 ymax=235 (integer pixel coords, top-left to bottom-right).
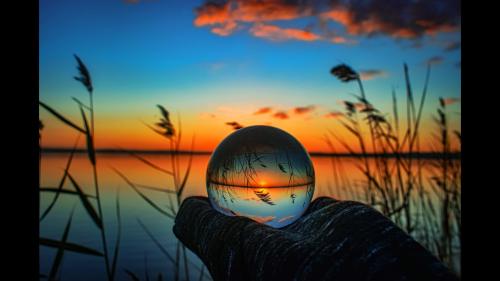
xmin=325 ymin=64 xmax=461 ymax=272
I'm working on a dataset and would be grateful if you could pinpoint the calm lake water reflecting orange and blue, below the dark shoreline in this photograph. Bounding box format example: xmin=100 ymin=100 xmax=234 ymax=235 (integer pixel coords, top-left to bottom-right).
xmin=40 ymin=153 xmax=460 ymax=281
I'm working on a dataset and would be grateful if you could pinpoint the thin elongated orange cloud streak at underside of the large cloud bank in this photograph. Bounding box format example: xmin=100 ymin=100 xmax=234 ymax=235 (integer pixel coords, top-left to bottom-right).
xmin=250 ymin=24 xmax=321 ymax=41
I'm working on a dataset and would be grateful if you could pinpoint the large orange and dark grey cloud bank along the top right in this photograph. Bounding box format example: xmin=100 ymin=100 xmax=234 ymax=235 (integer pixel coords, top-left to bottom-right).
xmin=194 ymin=0 xmax=460 ymax=43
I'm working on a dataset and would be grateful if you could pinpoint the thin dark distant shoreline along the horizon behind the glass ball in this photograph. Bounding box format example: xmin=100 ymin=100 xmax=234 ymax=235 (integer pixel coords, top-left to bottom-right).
xmin=42 ymin=148 xmax=461 ymax=159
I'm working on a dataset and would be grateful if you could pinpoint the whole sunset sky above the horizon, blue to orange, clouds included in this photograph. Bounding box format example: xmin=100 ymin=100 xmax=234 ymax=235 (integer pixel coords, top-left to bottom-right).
xmin=39 ymin=0 xmax=461 ymax=151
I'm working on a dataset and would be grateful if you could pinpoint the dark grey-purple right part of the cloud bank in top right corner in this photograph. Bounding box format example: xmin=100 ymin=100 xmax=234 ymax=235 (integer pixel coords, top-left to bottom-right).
xmin=320 ymin=0 xmax=460 ymax=38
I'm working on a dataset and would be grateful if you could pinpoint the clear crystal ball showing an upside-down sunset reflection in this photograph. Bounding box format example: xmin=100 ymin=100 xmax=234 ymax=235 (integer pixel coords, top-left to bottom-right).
xmin=206 ymin=126 xmax=314 ymax=228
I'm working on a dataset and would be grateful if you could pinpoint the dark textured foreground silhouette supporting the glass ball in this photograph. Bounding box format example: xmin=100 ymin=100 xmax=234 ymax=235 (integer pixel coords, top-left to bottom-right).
xmin=174 ymin=197 xmax=458 ymax=280
